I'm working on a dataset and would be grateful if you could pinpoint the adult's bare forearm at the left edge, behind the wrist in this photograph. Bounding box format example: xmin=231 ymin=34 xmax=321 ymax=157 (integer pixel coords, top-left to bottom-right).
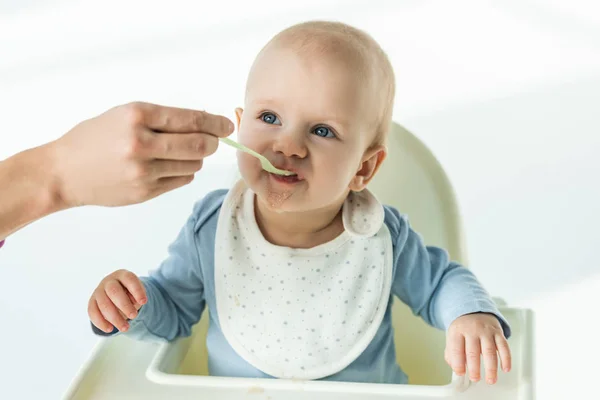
xmin=0 ymin=144 xmax=66 ymax=240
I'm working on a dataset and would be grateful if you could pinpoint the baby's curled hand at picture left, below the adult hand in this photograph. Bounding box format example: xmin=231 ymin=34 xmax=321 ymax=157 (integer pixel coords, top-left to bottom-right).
xmin=88 ymin=269 xmax=147 ymax=333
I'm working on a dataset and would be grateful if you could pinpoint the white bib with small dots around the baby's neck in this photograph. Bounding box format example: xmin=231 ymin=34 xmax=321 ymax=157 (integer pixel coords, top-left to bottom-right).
xmin=215 ymin=181 xmax=392 ymax=379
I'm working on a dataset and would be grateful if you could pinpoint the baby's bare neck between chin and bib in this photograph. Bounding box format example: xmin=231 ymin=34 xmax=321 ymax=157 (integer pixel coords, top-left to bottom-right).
xmin=254 ymin=198 xmax=344 ymax=249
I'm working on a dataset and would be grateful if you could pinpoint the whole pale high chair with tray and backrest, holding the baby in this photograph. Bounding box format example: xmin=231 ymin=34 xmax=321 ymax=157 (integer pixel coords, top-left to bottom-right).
xmin=64 ymin=123 xmax=535 ymax=400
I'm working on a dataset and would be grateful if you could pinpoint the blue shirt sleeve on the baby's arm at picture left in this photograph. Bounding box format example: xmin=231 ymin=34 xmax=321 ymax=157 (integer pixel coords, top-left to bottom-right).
xmin=92 ymin=201 xmax=211 ymax=341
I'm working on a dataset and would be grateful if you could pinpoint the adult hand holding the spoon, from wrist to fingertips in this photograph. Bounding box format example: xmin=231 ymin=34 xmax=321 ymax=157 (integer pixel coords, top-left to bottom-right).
xmin=50 ymin=103 xmax=234 ymax=208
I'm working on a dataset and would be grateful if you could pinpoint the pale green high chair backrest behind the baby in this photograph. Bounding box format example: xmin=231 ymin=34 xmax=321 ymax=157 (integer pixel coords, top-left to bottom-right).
xmin=368 ymin=122 xmax=467 ymax=384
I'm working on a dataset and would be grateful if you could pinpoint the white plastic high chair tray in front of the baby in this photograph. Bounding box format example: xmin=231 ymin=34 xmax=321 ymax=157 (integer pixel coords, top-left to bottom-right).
xmin=64 ymin=307 xmax=534 ymax=400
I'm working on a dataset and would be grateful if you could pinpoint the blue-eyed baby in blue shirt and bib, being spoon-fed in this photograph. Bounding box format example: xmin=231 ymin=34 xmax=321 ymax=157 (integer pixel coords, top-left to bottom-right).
xmin=89 ymin=22 xmax=511 ymax=383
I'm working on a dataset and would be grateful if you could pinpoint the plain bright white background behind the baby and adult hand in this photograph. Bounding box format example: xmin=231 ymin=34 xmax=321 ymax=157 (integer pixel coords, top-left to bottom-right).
xmin=0 ymin=0 xmax=600 ymax=399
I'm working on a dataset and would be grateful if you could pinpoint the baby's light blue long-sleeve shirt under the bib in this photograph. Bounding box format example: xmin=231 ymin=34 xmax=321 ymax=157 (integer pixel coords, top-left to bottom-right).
xmin=94 ymin=190 xmax=510 ymax=383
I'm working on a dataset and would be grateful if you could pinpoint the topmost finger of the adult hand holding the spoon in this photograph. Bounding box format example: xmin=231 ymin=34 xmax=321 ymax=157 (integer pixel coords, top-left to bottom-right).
xmin=136 ymin=103 xmax=234 ymax=136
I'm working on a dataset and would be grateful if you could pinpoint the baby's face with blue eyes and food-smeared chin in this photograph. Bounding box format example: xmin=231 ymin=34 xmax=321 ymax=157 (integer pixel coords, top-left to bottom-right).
xmin=236 ymin=48 xmax=377 ymax=212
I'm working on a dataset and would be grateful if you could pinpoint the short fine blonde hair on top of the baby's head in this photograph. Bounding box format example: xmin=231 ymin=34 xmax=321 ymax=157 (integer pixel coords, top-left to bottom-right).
xmin=252 ymin=21 xmax=396 ymax=146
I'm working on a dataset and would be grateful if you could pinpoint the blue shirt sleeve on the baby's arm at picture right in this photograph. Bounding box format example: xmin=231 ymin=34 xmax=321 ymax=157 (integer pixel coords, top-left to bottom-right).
xmin=386 ymin=208 xmax=511 ymax=338
